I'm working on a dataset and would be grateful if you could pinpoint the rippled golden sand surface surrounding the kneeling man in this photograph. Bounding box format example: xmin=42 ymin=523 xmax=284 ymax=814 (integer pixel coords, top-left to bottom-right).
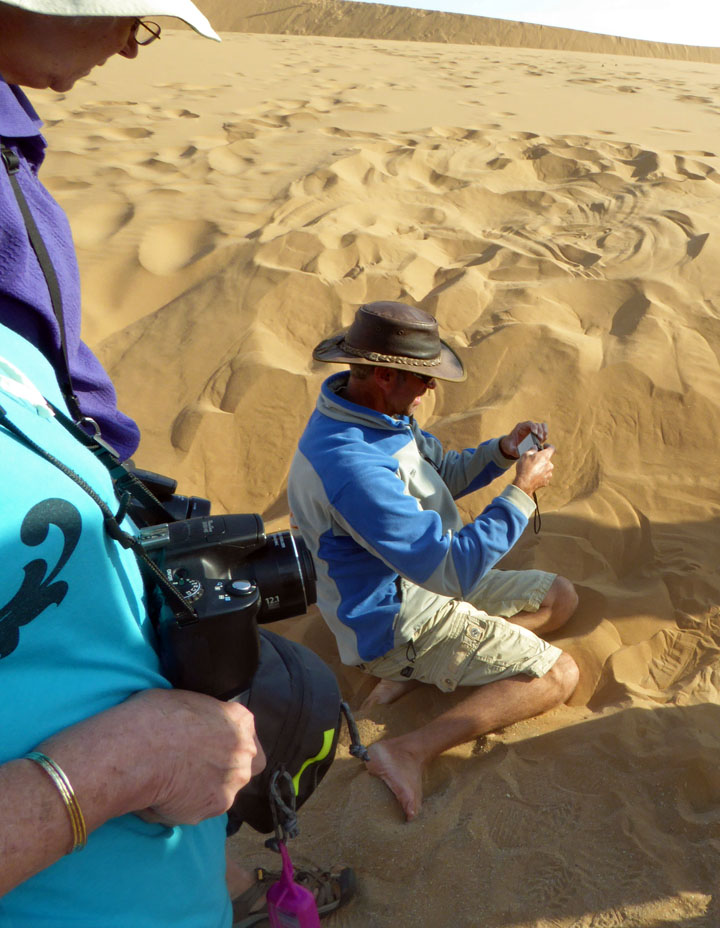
xmin=33 ymin=16 xmax=720 ymax=928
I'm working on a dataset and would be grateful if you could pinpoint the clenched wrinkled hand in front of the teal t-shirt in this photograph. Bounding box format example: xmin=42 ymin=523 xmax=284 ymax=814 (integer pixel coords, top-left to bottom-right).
xmin=126 ymin=690 xmax=265 ymax=825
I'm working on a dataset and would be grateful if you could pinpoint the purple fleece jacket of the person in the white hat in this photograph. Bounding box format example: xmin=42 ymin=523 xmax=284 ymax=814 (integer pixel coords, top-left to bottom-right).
xmin=0 ymin=77 xmax=140 ymax=460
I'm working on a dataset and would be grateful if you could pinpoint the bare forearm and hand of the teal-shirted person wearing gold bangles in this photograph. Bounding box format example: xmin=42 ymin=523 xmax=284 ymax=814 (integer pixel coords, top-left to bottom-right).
xmin=0 ymin=689 xmax=265 ymax=895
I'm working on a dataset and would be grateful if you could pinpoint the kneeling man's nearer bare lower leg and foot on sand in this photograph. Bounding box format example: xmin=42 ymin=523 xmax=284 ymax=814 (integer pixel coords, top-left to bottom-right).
xmin=367 ymin=653 xmax=578 ymax=821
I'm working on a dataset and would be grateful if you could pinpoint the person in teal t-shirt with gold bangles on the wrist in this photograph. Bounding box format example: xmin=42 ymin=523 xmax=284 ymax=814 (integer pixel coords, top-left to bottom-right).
xmin=0 ymin=325 xmax=263 ymax=928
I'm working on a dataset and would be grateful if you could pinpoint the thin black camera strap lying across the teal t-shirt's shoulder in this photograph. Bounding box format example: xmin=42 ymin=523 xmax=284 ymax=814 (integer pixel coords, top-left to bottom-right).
xmin=0 ymin=404 xmax=197 ymax=629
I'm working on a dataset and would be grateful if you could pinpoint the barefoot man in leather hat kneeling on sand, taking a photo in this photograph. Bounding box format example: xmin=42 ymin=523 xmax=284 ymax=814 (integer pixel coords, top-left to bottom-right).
xmin=288 ymin=302 xmax=578 ymax=820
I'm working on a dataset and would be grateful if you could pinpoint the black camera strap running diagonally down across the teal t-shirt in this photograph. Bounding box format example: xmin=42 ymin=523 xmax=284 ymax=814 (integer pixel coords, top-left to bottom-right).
xmin=0 ymin=403 xmax=197 ymax=628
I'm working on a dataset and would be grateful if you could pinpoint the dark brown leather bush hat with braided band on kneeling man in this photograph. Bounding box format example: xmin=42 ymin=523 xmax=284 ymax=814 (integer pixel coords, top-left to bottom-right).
xmin=313 ymin=301 xmax=466 ymax=381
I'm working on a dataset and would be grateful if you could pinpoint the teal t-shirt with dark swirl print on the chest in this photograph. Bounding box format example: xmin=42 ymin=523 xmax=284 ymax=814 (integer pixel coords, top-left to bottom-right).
xmin=0 ymin=325 xmax=232 ymax=928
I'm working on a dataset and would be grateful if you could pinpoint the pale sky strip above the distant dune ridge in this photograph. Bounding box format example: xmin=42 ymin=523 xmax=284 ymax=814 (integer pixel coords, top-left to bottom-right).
xmin=354 ymin=0 xmax=720 ymax=46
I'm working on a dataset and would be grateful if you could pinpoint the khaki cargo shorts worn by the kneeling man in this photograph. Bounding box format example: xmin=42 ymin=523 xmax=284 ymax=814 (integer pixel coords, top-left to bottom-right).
xmin=362 ymin=570 xmax=562 ymax=693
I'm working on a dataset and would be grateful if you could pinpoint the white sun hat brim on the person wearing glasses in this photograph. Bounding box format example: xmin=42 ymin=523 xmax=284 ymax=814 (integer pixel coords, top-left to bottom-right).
xmin=3 ymin=0 xmax=220 ymax=42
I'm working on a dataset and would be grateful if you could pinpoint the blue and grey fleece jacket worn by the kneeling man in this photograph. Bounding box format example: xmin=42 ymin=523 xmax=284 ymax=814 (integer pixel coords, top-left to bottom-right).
xmin=288 ymin=372 xmax=534 ymax=664
